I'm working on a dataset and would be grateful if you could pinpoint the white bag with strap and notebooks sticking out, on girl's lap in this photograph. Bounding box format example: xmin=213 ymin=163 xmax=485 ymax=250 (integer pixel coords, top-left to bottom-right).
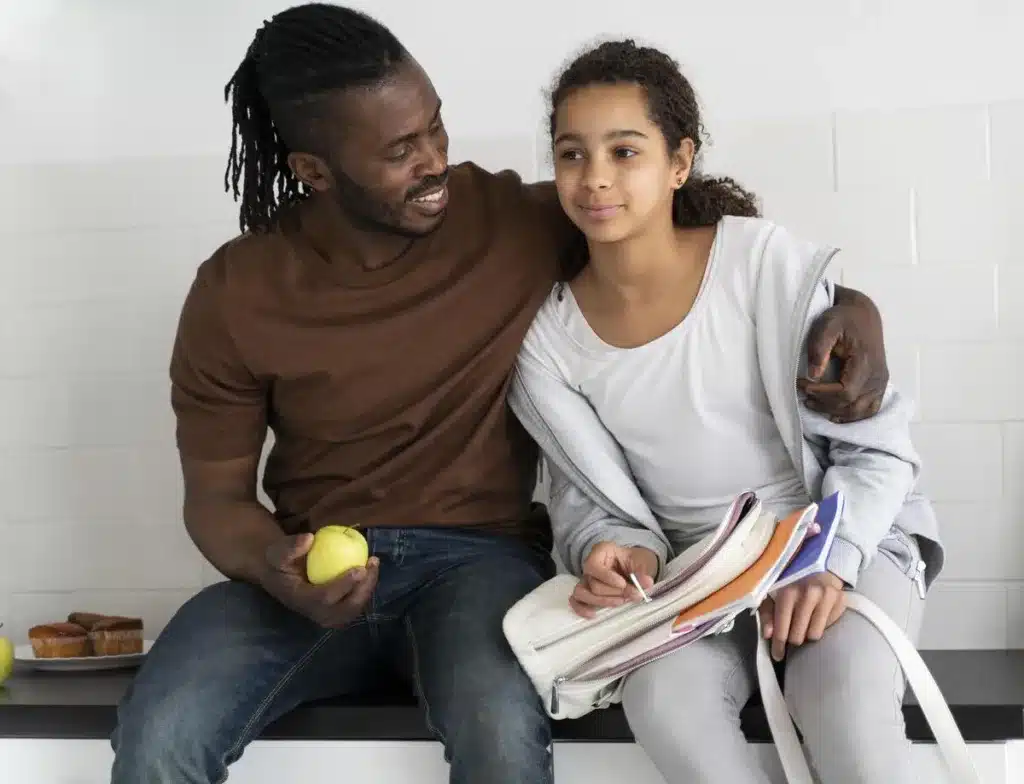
xmin=503 ymin=492 xmax=981 ymax=784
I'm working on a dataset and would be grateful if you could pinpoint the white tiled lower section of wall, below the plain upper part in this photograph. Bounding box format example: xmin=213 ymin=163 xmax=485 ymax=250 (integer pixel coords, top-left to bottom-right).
xmin=0 ymin=110 xmax=1024 ymax=647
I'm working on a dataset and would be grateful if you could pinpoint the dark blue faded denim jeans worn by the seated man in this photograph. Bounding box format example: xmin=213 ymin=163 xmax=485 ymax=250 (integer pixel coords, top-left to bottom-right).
xmin=112 ymin=528 xmax=554 ymax=784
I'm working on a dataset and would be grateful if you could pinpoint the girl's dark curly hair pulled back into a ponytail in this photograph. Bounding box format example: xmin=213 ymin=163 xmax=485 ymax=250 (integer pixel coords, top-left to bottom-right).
xmin=550 ymin=39 xmax=760 ymax=277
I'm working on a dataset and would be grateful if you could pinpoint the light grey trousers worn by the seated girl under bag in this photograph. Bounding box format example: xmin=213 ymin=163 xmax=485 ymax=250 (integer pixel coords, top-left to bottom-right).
xmin=623 ymin=536 xmax=925 ymax=784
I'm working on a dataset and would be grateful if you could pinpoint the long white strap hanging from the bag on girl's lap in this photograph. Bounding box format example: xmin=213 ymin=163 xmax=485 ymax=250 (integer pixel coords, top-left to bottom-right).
xmin=755 ymin=591 xmax=981 ymax=784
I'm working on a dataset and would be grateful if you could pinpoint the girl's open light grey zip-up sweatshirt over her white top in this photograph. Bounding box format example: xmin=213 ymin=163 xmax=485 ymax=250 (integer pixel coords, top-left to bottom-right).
xmin=509 ymin=218 xmax=944 ymax=586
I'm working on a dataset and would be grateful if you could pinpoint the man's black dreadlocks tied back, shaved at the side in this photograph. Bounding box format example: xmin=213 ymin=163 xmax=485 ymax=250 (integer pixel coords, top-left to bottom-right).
xmin=224 ymin=3 xmax=407 ymax=231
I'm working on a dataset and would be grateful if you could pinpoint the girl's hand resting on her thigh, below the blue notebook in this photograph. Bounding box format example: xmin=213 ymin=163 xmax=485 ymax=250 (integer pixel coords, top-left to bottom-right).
xmin=758 ymin=572 xmax=846 ymax=661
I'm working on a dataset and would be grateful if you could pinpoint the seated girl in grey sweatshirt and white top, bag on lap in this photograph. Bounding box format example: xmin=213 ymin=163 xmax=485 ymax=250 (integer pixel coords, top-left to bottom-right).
xmin=511 ymin=41 xmax=943 ymax=784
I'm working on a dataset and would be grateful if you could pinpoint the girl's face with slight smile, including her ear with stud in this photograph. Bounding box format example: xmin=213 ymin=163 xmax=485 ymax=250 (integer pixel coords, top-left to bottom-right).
xmin=554 ymin=84 xmax=692 ymax=243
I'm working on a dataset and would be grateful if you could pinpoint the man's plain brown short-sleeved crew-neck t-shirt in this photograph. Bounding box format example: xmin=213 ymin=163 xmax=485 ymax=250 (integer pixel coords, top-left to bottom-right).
xmin=171 ymin=164 xmax=564 ymax=548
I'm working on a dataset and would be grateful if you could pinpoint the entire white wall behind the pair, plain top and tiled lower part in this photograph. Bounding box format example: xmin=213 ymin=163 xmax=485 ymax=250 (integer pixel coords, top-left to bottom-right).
xmin=0 ymin=0 xmax=1024 ymax=648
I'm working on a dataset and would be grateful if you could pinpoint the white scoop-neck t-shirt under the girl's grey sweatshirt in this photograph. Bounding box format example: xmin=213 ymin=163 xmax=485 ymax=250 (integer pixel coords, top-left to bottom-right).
xmin=544 ymin=227 xmax=810 ymax=548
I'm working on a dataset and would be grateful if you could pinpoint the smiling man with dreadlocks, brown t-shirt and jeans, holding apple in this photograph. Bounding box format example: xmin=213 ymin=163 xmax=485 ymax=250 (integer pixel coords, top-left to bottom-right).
xmin=113 ymin=4 xmax=888 ymax=784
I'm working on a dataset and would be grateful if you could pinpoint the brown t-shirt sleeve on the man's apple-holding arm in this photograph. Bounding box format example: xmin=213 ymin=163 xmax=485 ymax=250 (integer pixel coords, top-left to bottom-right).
xmin=170 ymin=262 xmax=267 ymax=461
